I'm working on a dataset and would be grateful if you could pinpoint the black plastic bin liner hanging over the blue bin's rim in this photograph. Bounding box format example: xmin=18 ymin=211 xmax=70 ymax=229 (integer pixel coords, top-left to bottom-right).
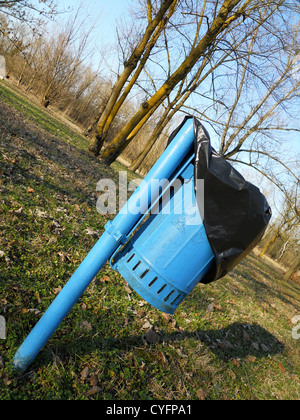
xmin=169 ymin=116 xmax=272 ymax=284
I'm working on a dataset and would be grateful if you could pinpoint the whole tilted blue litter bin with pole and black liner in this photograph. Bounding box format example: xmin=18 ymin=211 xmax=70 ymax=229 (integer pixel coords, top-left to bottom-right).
xmin=13 ymin=117 xmax=272 ymax=373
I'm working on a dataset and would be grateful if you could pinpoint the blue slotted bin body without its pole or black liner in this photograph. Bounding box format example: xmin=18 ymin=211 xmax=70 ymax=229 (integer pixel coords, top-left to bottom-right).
xmin=111 ymin=159 xmax=215 ymax=314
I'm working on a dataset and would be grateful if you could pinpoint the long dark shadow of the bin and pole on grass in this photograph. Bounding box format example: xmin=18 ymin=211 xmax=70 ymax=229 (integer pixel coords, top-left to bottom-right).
xmin=51 ymin=323 xmax=284 ymax=361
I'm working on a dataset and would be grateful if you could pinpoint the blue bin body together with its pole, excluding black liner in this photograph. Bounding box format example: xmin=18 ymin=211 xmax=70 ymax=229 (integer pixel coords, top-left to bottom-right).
xmin=13 ymin=120 xmax=214 ymax=373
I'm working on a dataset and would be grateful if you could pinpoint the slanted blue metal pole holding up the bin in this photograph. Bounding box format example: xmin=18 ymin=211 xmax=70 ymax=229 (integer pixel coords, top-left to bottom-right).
xmin=13 ymin=116 xmax=194 ymax=373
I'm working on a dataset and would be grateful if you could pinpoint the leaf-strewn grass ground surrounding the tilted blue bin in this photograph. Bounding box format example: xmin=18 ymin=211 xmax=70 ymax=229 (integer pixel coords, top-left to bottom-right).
xmin=0 ymin=79 xmax=300 ymax=400
